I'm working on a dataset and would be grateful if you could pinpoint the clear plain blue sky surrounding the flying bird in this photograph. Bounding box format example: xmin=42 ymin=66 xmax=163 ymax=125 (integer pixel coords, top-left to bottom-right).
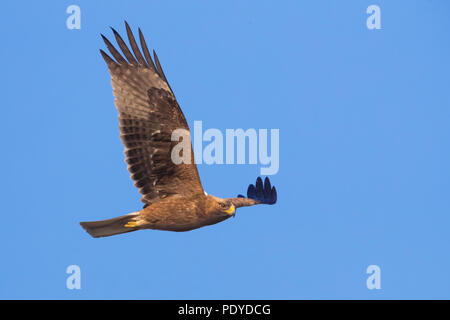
xmin=0 ymin=0 xmax=450 ymax=299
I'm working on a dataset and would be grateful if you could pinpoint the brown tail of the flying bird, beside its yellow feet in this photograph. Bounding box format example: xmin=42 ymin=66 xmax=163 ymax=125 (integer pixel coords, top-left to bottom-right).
xmin=80 ymin=212 xmax=139 ymax=238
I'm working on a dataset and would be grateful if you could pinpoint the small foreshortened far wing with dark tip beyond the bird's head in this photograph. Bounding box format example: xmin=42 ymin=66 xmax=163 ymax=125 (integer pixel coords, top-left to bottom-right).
xmin=229 ymin=177 xmax=277 ymax=208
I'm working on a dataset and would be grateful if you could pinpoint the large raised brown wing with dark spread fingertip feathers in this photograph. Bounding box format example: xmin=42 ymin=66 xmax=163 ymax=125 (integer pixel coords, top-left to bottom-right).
xmin=100 ymin=22 xmax=204 ymax=205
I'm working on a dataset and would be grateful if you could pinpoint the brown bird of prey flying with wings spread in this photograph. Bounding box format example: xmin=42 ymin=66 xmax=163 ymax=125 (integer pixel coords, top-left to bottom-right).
xmin=80 ymin=21 xmax=277 ymax=238
